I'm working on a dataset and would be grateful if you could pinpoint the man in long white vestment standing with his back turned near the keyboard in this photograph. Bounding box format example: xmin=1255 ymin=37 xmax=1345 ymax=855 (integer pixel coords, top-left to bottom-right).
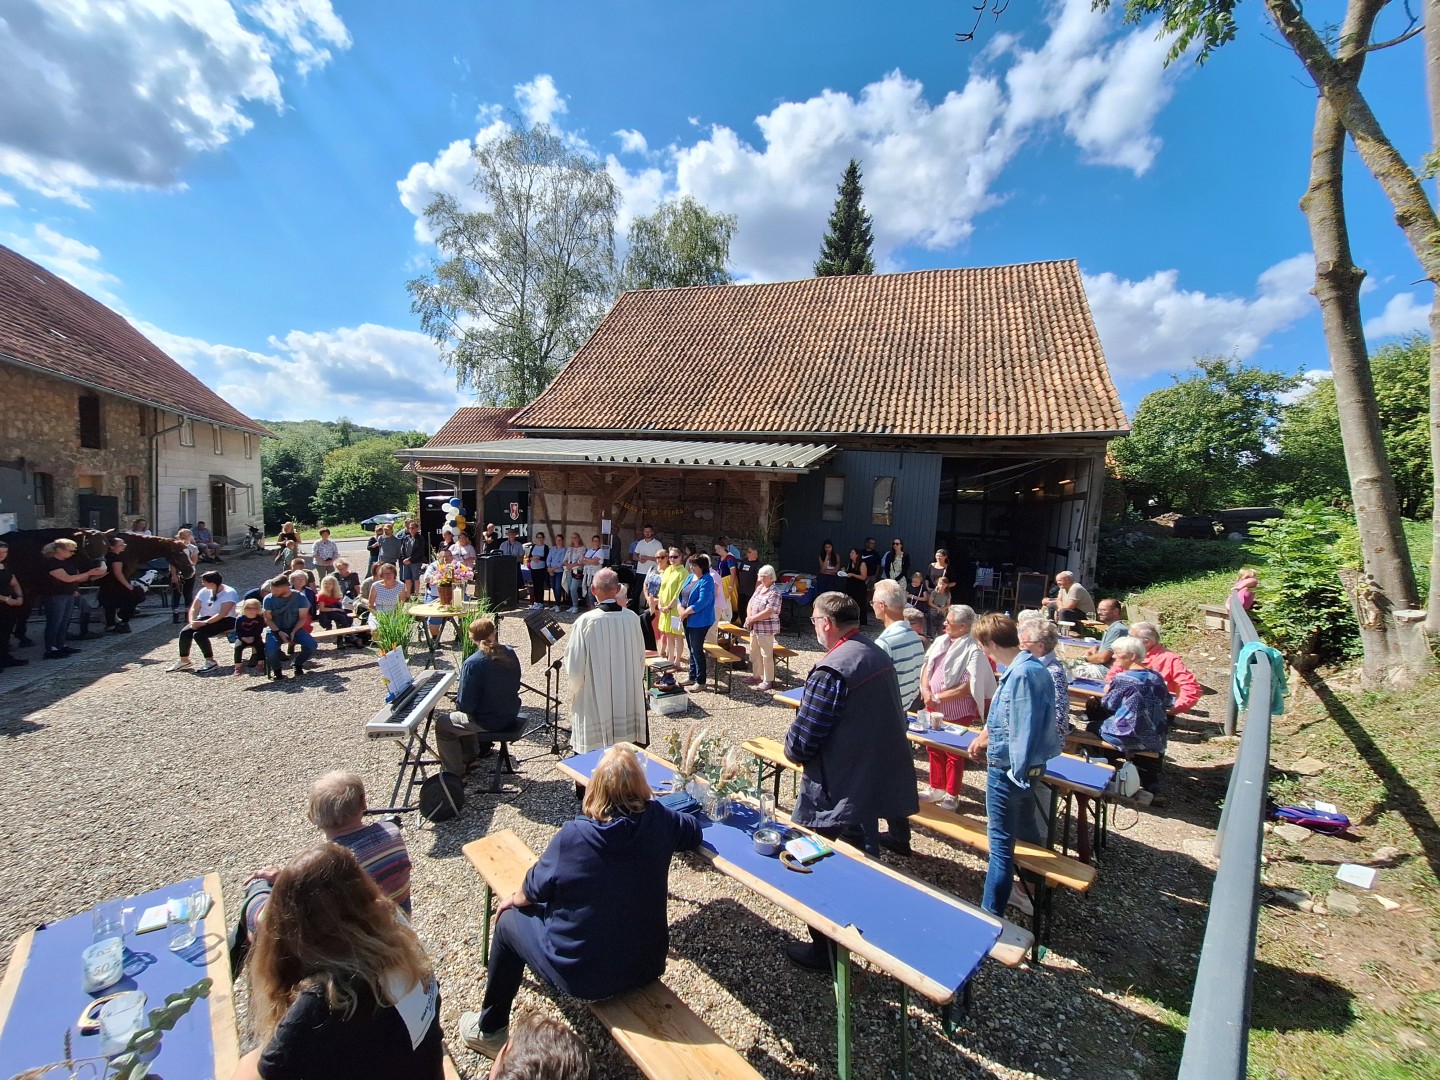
xmin=564 ymin=567 xmax=649 ymax=753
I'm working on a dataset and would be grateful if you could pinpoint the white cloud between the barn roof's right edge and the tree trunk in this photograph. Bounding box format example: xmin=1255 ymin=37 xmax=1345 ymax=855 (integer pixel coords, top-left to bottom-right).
xmin=1084 ymin=253 xmax=1315 ymax=382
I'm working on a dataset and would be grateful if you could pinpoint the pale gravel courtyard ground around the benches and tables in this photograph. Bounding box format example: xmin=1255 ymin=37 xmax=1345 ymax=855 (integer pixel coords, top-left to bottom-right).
xmin=0 ymin=559 xmax=1224 ymax=1080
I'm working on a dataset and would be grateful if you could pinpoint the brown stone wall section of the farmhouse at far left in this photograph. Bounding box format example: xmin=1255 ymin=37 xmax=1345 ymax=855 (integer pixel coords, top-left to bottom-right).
xmin=0 ymin=364 xmax=153 ymax=528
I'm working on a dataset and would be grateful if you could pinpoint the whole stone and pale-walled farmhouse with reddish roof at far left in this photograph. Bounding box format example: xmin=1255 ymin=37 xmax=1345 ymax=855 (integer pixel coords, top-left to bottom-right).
xmin=0 ymin=246 xmax=269 ymax=537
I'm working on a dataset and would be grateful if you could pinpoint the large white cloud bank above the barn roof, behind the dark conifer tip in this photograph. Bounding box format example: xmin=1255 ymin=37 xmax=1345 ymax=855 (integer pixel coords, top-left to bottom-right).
xmin=400 ymin=0 xmax=1179 ymax=281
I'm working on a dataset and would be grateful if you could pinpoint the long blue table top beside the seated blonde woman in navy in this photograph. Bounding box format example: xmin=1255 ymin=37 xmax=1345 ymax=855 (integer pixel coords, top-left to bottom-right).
xmin=562 ymin=750 xmax=1001 ymax=992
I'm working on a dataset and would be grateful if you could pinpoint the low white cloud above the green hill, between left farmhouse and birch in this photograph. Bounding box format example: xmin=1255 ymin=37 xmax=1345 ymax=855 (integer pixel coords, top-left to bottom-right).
xmin=135 ymin=323 xmax=472 ymax=432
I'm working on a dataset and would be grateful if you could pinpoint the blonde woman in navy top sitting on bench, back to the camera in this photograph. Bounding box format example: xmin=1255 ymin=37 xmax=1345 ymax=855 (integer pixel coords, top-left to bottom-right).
xmin=461 ymin=743 xmax=700 ymax=1057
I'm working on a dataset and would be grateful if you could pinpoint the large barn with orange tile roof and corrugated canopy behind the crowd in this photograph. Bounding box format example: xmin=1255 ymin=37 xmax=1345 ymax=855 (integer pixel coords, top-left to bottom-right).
xmin=403 ymin=261 xmax=1129 ymax=601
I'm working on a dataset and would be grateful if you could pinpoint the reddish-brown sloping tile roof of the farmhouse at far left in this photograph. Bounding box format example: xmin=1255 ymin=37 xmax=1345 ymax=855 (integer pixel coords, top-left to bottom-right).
xmin=0 ymin=246 xmax=271 ymax=435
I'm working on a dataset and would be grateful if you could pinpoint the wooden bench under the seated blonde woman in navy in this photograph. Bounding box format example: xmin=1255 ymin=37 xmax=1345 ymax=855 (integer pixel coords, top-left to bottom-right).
xmin=464 ymin=829 xmax=760 ymax=1080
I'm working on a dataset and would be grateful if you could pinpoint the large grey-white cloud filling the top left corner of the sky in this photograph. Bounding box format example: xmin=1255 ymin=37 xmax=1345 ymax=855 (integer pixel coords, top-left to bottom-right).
xmin=0 ymin=0 xmax=350 ymax=206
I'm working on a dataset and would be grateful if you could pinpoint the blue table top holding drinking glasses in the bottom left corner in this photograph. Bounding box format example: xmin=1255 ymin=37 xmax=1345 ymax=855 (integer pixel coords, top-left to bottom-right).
xmin=0 ymin=878 xmax=229 ymax=1080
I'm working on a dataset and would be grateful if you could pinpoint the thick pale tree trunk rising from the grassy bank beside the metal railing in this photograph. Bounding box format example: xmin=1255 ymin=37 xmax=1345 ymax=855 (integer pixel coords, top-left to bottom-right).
xmin=1300 ymin=4 xmax=1417 ymax=684
